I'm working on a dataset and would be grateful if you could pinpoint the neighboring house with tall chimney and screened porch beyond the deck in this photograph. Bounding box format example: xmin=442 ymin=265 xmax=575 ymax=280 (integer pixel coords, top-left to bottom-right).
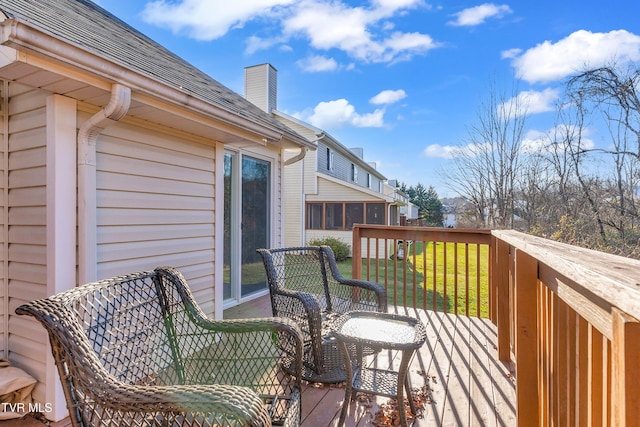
xmin=245 ymin=64 xmax=398 ymax=258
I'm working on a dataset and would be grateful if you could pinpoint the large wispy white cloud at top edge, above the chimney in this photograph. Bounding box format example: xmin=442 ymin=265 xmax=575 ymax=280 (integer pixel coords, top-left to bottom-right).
xmin=142 ymin=0 xmax=440 ymax=62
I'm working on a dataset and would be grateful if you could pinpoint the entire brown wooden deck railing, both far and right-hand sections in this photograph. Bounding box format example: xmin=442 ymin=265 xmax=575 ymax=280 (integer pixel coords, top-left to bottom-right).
xmin=352 ymin=225 xmax=640 ymax=426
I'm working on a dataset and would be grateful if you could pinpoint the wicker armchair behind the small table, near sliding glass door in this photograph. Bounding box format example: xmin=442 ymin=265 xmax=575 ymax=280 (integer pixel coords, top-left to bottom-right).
xmin=258 ymin=246 xmax=387 ymax=383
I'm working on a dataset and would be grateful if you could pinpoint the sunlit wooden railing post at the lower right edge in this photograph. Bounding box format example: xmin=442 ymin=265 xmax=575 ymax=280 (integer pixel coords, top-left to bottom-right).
xmin=611 ymin=308 xmax=640 ymax=426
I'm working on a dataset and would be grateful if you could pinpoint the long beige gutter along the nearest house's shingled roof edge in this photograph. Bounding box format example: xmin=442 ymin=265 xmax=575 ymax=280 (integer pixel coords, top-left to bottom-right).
xmin=0 ymin=18 xmax=309 ymax=147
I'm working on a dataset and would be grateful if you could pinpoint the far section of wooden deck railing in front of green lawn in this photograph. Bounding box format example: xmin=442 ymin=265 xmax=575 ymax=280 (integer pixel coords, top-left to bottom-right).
xmin=352 ymin=225 xmax=491 ymax=317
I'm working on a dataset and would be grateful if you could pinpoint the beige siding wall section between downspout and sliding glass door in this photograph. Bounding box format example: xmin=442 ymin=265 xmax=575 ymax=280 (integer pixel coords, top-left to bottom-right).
xmin=96 ymin=123 xmax=215 ymax=315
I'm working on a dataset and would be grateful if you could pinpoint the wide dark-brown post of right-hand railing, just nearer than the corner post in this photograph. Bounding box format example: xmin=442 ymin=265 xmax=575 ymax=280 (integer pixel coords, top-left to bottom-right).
xmin=515 ymin=250 xmax=539 ymax=426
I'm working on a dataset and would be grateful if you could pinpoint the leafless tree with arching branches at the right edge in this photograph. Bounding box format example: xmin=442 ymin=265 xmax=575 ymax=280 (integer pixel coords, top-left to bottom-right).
xmin=567 ymin=64 xmax=640 ymax=251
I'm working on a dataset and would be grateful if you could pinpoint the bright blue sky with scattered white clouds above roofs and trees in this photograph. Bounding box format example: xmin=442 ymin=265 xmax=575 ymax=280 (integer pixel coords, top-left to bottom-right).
xmin=97 ymin=0 xmax=640 ymax=197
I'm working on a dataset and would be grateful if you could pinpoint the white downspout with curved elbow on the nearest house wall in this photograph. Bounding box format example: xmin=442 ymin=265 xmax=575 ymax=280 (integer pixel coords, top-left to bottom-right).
xmin=78 ymin=84 xmax=131 ymax=284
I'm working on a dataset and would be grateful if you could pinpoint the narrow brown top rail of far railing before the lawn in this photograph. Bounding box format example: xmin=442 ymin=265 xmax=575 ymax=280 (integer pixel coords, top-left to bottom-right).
xmin=353 ymin=224 xmax=491 ymax=243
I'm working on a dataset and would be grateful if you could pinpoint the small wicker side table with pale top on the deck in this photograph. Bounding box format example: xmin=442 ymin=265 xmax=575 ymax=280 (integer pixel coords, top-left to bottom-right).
xmin=332 ymin=311 xmax=427 ymax=426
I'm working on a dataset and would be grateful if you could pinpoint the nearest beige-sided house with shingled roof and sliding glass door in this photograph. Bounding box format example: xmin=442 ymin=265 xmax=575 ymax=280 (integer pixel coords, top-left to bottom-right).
xmin=0 ymin=0 xmax=315 ymax=420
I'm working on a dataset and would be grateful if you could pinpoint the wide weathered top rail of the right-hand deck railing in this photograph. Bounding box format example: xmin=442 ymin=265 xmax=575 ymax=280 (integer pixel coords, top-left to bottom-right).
xmin=492 ymin=230 xmax=640 ymax=319
